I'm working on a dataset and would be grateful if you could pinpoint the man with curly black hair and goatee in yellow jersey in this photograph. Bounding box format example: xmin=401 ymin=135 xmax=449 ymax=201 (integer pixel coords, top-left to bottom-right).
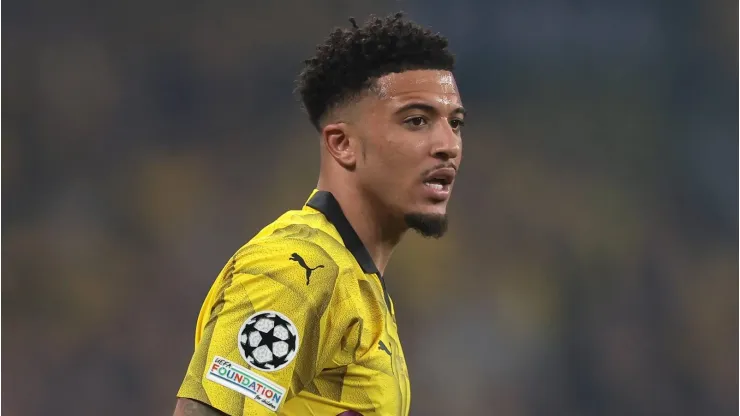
xmin=175 ymin=14 xmax=465 ymax=416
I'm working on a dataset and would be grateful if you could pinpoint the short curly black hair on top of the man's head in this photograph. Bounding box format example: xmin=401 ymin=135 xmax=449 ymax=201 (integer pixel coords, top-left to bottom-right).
xmin=297 ymin=13 xmax=455 ymax=131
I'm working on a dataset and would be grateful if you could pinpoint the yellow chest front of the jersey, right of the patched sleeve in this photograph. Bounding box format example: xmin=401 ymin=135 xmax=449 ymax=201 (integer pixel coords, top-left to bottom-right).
xmin=284 ymin=275 xmax=411 ymax=416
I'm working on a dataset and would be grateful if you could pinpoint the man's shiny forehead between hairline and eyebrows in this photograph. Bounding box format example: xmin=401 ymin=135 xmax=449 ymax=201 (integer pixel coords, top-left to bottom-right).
xmin=375 ymin=70 xmax=460 ymax=103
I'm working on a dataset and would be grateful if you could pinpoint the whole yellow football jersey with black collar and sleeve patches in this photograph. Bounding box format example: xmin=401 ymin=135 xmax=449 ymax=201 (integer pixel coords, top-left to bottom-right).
xmin=177 ymin=190 xmax=410 ymax=416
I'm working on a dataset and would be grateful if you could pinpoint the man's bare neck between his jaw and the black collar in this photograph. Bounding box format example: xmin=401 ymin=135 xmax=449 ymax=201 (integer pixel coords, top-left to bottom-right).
xmin=317 ymin=178 xmax=405 ymax=274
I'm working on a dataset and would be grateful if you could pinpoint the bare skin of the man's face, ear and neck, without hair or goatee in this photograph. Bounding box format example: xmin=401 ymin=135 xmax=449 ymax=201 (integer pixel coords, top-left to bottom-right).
xmin=318 ymin=70 xmax=464 ymax=272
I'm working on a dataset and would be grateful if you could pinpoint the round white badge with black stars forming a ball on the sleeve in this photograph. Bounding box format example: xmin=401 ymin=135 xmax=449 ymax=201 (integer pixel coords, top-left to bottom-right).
xmin=238 ymin=311 xmax=298 ymax=371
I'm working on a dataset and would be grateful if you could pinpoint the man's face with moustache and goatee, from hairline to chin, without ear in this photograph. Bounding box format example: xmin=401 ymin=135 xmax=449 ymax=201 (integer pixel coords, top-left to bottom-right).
xmin=346 ymin=70 xmax=465 ymax=236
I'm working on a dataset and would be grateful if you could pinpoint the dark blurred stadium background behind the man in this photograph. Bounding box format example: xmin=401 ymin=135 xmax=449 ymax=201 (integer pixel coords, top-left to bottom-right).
xmin=2 ymin=0 xmax=738 ymax=416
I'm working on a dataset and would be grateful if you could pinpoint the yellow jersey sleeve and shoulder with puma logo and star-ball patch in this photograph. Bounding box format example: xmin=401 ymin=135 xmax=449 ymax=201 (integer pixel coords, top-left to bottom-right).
xmin=178 ymin=240 xmax=351 ymax=416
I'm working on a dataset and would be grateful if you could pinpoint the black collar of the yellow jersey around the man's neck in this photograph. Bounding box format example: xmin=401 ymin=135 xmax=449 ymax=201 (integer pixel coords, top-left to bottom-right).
xmin=306 ymin=190 xmax=380 ymax=275
